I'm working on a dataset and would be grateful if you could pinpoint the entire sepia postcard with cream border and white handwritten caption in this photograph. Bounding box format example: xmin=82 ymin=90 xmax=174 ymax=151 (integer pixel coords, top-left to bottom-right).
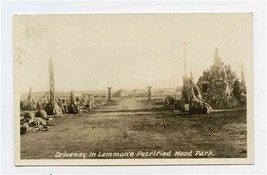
xmin=13 ymin=13 xmax=254 ymax=166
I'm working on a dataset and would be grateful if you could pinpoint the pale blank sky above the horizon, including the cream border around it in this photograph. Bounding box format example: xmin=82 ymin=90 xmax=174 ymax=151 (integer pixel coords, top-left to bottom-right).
xmin=14 ymin=14 xmax=253 ymax=92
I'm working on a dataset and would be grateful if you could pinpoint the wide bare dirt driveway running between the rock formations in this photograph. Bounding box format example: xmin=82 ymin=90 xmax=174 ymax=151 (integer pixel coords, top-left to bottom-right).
xmin=21 ymin=97 xmax=247 ymax=159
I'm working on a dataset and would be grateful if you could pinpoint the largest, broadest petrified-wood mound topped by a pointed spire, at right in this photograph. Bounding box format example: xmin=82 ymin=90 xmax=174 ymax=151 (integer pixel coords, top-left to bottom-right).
xmin=197 ymin=49 xmax=239 ymax=108
